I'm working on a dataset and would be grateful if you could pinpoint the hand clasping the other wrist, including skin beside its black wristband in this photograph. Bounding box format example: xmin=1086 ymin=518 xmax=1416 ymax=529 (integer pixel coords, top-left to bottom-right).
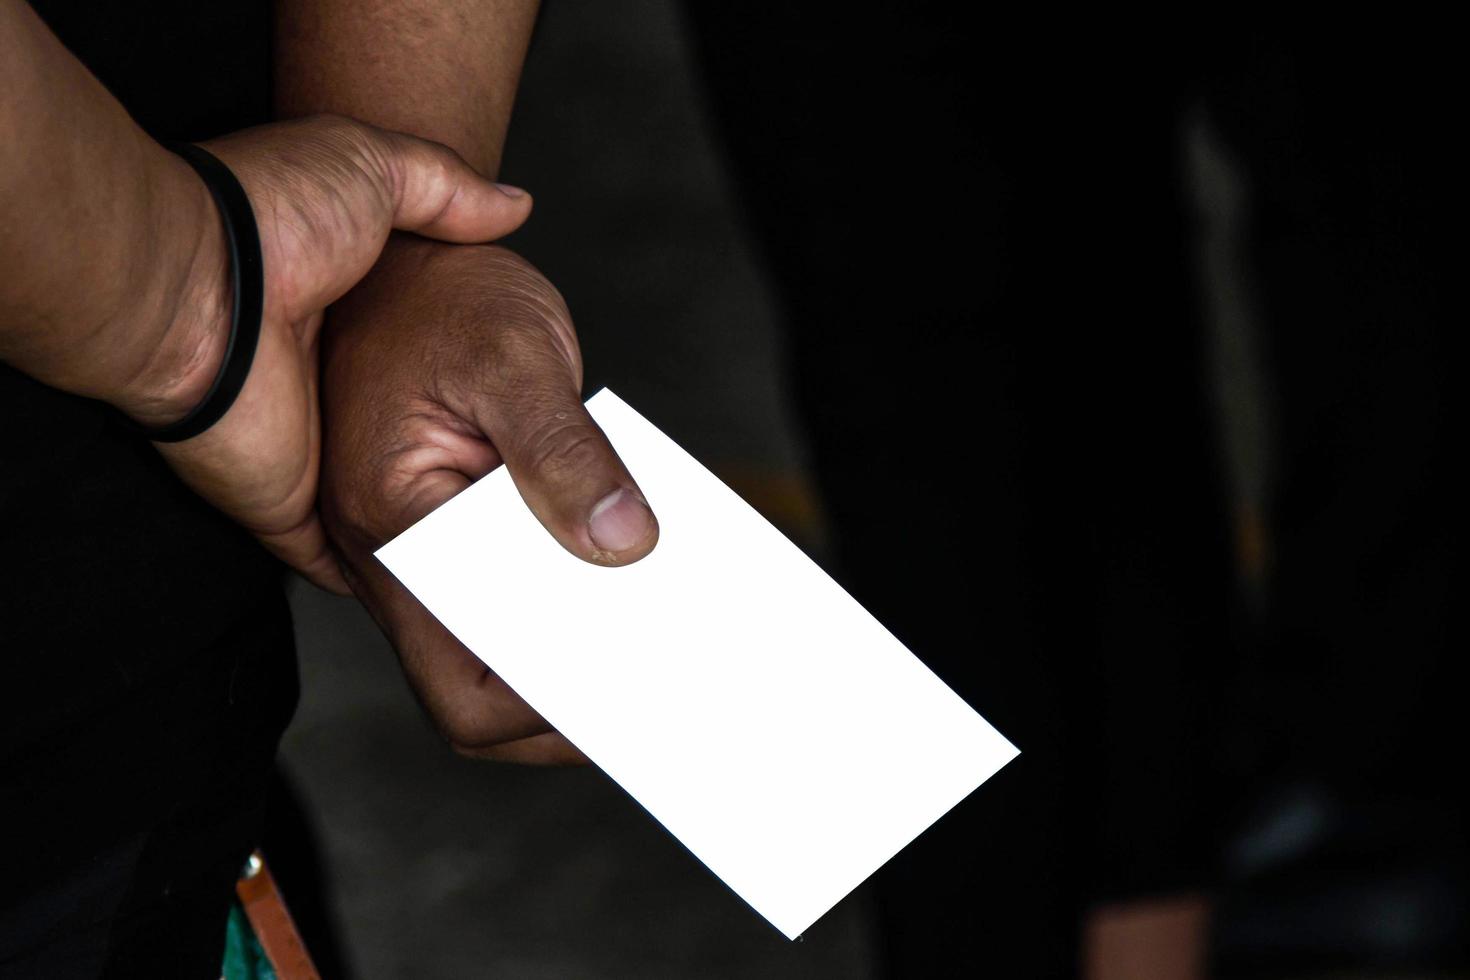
xmin=123 ymin=116 xmax=531 ymax=592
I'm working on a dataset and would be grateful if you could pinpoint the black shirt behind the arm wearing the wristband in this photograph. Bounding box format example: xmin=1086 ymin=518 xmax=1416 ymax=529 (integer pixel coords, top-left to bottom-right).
xmin=0 ymin=1 xmax=281 ymax=754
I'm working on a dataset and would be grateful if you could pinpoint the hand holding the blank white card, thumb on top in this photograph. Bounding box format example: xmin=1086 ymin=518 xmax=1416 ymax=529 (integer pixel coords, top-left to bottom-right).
xmin=322 ymin=237 xmax=659 ymax=763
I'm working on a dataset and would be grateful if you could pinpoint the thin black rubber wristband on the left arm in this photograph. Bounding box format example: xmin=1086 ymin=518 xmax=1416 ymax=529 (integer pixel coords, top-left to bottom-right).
xmin=134 ymin=143 xmax=266 ymax=442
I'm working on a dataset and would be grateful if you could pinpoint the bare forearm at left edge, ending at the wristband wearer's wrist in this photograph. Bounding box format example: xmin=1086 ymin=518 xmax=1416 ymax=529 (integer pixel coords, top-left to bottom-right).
xmin=0 ymin=0 xmax=223 ymax=422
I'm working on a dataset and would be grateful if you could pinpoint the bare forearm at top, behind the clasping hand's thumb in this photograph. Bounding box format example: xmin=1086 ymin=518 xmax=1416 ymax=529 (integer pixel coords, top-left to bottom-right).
xmin=276 ymin=0 xmax=537 ymax=176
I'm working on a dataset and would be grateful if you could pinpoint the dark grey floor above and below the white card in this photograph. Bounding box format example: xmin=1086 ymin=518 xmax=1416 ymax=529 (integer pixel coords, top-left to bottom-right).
xmin=284 ymin=0 xmax=872 ymax=980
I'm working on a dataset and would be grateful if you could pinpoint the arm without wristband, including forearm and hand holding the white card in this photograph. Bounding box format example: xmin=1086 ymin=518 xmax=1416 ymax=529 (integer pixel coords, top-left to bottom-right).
xmin=276 ymin=0 xmax=657 ymax=763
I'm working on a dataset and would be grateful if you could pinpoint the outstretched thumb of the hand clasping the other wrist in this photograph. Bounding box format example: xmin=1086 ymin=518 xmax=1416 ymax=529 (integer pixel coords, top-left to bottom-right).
xmin=378 ymin=131 xmax=531 ymax=244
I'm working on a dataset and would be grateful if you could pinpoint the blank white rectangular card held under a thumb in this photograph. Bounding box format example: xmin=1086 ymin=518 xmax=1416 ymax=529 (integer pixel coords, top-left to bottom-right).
xmin=378 ymin=389 xmax=1016 ymax=939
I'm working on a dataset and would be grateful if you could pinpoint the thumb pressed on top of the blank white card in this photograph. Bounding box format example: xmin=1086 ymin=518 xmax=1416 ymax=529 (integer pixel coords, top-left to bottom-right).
xmin=475 ymin=373 xmax=659 ymax=566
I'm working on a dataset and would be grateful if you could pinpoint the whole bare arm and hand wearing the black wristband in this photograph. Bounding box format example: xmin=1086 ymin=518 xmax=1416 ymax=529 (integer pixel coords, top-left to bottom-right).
xmin=0 ymin=0 xmax=529 ymax=586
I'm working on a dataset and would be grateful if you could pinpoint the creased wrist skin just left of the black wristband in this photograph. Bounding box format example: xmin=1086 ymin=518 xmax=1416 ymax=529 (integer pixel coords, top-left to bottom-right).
xmin=103 ymin=144 xmax=232 ymax=426
